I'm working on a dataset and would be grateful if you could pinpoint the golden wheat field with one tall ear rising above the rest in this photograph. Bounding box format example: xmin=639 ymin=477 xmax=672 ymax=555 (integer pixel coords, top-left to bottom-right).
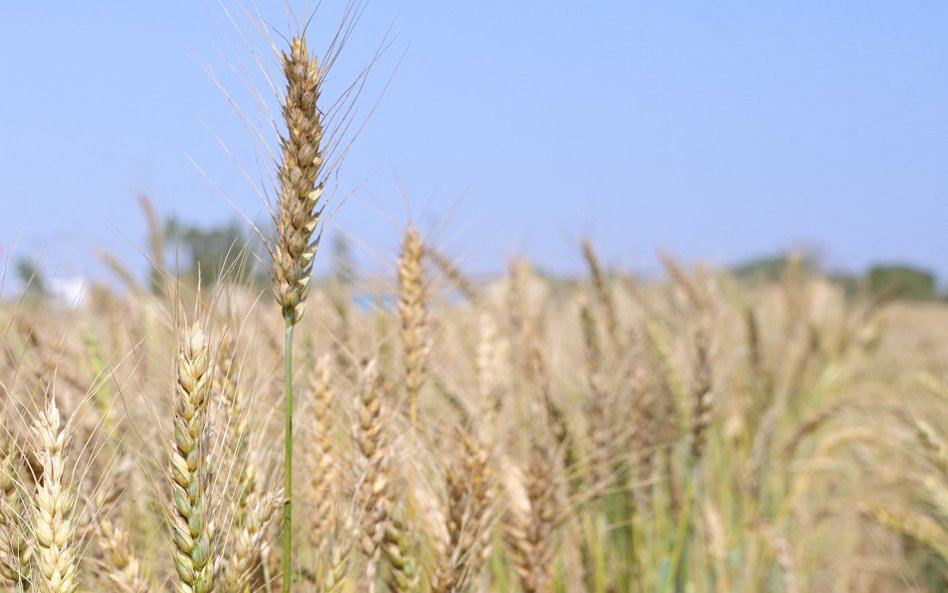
xmin=0 ymin=11 xmax=948 ymax=593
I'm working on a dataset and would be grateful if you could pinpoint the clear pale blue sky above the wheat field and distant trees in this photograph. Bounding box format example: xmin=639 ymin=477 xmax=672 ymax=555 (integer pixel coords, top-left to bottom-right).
xmin=0 ymin=0 xmax=948 ymax=278
